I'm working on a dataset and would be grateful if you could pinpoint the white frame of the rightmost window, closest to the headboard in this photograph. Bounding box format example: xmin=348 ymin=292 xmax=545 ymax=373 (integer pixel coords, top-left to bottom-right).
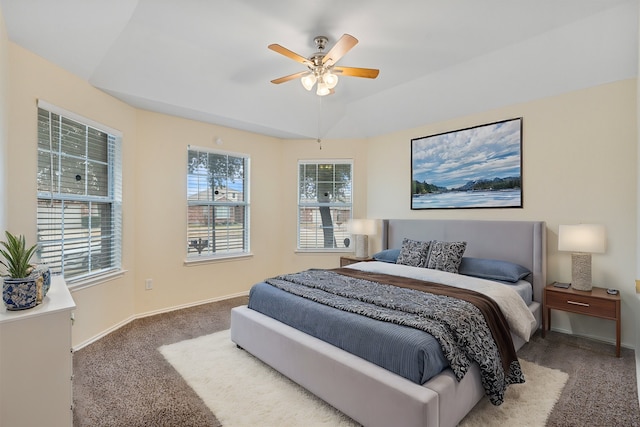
xmin=296 ymin=159 xmax=354 ymax=253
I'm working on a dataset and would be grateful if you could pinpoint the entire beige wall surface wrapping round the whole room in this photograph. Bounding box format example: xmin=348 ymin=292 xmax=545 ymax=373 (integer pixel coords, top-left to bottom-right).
xmin=0 ymin=30 xmax=637 ymax=352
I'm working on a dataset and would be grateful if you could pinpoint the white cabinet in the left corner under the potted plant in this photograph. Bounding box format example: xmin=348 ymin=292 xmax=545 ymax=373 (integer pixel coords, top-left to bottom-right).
xmin=0 ymin=276 xmax=76 ymax=427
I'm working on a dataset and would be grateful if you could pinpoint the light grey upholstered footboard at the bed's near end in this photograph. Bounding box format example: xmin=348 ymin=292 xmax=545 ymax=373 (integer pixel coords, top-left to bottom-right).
xmin=231 ymin=306 xmax=440 ymax=427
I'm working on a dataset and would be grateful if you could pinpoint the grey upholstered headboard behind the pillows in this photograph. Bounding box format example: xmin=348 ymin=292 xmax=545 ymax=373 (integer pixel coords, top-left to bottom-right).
xmin=382 ymin=219 xmax=547 ymax=304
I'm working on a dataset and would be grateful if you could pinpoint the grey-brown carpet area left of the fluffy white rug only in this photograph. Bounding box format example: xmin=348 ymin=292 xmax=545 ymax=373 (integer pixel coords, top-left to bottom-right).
xmin=73 ymin=298 xmax=247 ymax=427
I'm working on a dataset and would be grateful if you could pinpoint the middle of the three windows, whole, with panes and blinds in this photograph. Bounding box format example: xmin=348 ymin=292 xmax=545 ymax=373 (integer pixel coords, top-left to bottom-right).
xmin=187 ymin=147 xmax=249 ymax=259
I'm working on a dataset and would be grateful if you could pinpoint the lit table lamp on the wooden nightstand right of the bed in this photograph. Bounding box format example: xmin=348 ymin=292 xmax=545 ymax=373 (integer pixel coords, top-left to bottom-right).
xmin=558 ymin=224 xmax=605 ymax=291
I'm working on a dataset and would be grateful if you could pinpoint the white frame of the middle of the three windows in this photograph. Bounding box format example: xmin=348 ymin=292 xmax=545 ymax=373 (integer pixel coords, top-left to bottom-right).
xmin=185 ymin=145 xmax=252 ymax=264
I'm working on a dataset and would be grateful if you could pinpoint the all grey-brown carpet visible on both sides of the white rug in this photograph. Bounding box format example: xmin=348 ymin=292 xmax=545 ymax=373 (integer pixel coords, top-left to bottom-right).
xmin=73 ymin=298 xmax=640 ymax=427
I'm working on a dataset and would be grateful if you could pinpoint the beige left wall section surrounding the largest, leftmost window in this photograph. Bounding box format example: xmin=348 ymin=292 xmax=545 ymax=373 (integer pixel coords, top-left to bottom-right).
xmin=3 ymin=43 xmax=136 ymax=344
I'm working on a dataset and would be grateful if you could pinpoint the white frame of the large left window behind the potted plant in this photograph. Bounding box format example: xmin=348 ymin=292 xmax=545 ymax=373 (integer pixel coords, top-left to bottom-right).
xmin=36 ymin=99 xmax=124 ymax=288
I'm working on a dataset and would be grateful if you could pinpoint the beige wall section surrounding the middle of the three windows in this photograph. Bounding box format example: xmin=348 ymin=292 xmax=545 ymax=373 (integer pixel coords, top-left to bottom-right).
xmin=134 ymin=111 xmax=284 ymax=313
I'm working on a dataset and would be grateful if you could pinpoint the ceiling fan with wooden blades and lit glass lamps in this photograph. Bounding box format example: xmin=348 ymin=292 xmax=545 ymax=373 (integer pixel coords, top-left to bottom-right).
xmin=269 ymin=34 xmax=380 ymax=96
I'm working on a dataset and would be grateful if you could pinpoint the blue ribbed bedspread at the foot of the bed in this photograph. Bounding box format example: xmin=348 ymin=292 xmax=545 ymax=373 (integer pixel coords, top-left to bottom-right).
xmin=249 ymin=282 xmax=449 ymax=384
